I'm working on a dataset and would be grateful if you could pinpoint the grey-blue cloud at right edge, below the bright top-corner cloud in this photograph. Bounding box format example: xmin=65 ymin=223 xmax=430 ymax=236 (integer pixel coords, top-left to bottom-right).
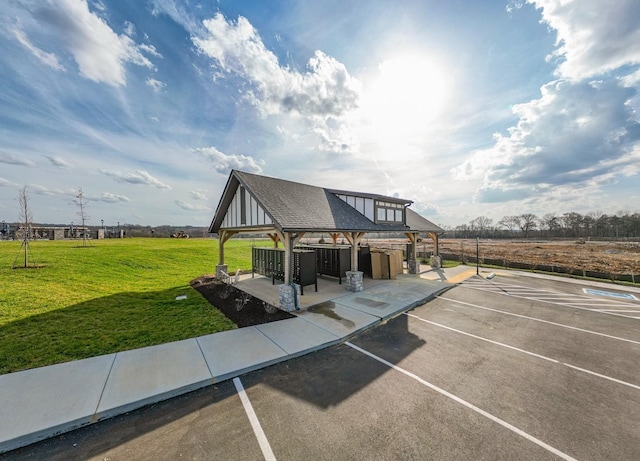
xmin=464 ymin=79 xmax=640 ymax=202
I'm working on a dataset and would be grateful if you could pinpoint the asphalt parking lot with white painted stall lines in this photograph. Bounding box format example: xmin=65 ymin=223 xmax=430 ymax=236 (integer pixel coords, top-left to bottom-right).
xmin=4 ymin=275 xmax=640 ymax=460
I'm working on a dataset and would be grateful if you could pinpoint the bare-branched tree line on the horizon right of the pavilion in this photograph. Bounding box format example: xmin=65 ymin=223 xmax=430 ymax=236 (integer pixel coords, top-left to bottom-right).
xmin=441 ymin=211 xmax=640 ymax=239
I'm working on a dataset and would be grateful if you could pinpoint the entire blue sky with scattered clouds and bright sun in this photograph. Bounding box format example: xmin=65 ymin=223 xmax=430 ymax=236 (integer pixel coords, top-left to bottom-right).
xmin=0 ymin=0 xmax=640 ymax=226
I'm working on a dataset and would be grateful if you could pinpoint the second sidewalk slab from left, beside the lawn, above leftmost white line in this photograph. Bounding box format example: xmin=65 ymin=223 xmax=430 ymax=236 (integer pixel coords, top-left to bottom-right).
xmin=97 ymin=339 xmax=212 ymax=419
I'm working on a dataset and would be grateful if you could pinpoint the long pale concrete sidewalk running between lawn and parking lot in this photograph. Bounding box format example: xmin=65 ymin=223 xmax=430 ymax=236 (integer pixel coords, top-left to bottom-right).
xmin=0 ymin=266 xmax=464 ymax=453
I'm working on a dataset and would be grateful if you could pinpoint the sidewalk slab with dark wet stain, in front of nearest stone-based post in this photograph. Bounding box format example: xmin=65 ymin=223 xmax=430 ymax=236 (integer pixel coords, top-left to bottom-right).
xmin=297 ymin=297 xmax=380 ymax=339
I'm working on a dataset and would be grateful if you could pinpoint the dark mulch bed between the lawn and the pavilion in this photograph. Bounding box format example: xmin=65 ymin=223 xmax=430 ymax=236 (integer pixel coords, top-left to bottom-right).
xmin=190 ymin=276 xmax=295 ymax=328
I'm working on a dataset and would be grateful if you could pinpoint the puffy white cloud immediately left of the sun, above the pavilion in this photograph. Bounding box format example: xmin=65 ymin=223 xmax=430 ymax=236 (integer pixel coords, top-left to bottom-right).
xmin=192 ymin=13 xmax=362 ymax=153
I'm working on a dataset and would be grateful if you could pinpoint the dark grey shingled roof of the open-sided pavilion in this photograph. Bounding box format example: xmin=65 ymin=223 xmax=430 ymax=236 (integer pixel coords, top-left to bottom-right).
xmin=209 ymin=170 xmax=443 ymax=232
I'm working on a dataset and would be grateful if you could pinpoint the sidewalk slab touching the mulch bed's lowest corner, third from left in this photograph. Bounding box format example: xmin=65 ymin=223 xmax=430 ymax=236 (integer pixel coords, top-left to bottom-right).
xmin=197 ymin=327 xmax=287 ymax=382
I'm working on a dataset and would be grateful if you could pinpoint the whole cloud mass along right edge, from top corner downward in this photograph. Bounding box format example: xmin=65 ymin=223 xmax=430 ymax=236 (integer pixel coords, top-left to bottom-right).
xmin=451 ymin=0 xmax=640 ymax=210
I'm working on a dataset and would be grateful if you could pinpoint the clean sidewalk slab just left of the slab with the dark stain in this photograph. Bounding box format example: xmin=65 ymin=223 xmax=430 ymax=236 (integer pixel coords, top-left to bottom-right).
xmin=256 ymin=317 xmax=340 ymax=358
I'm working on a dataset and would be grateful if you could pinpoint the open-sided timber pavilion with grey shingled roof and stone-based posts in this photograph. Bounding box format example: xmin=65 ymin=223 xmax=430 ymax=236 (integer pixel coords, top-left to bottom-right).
xmin=209 ymin=170 xmax=444 ymax=306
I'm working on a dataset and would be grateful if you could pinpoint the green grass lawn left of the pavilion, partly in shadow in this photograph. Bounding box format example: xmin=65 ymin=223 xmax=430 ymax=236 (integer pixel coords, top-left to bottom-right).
xmin=0 ymin=238 xmax=260 ymax=374
